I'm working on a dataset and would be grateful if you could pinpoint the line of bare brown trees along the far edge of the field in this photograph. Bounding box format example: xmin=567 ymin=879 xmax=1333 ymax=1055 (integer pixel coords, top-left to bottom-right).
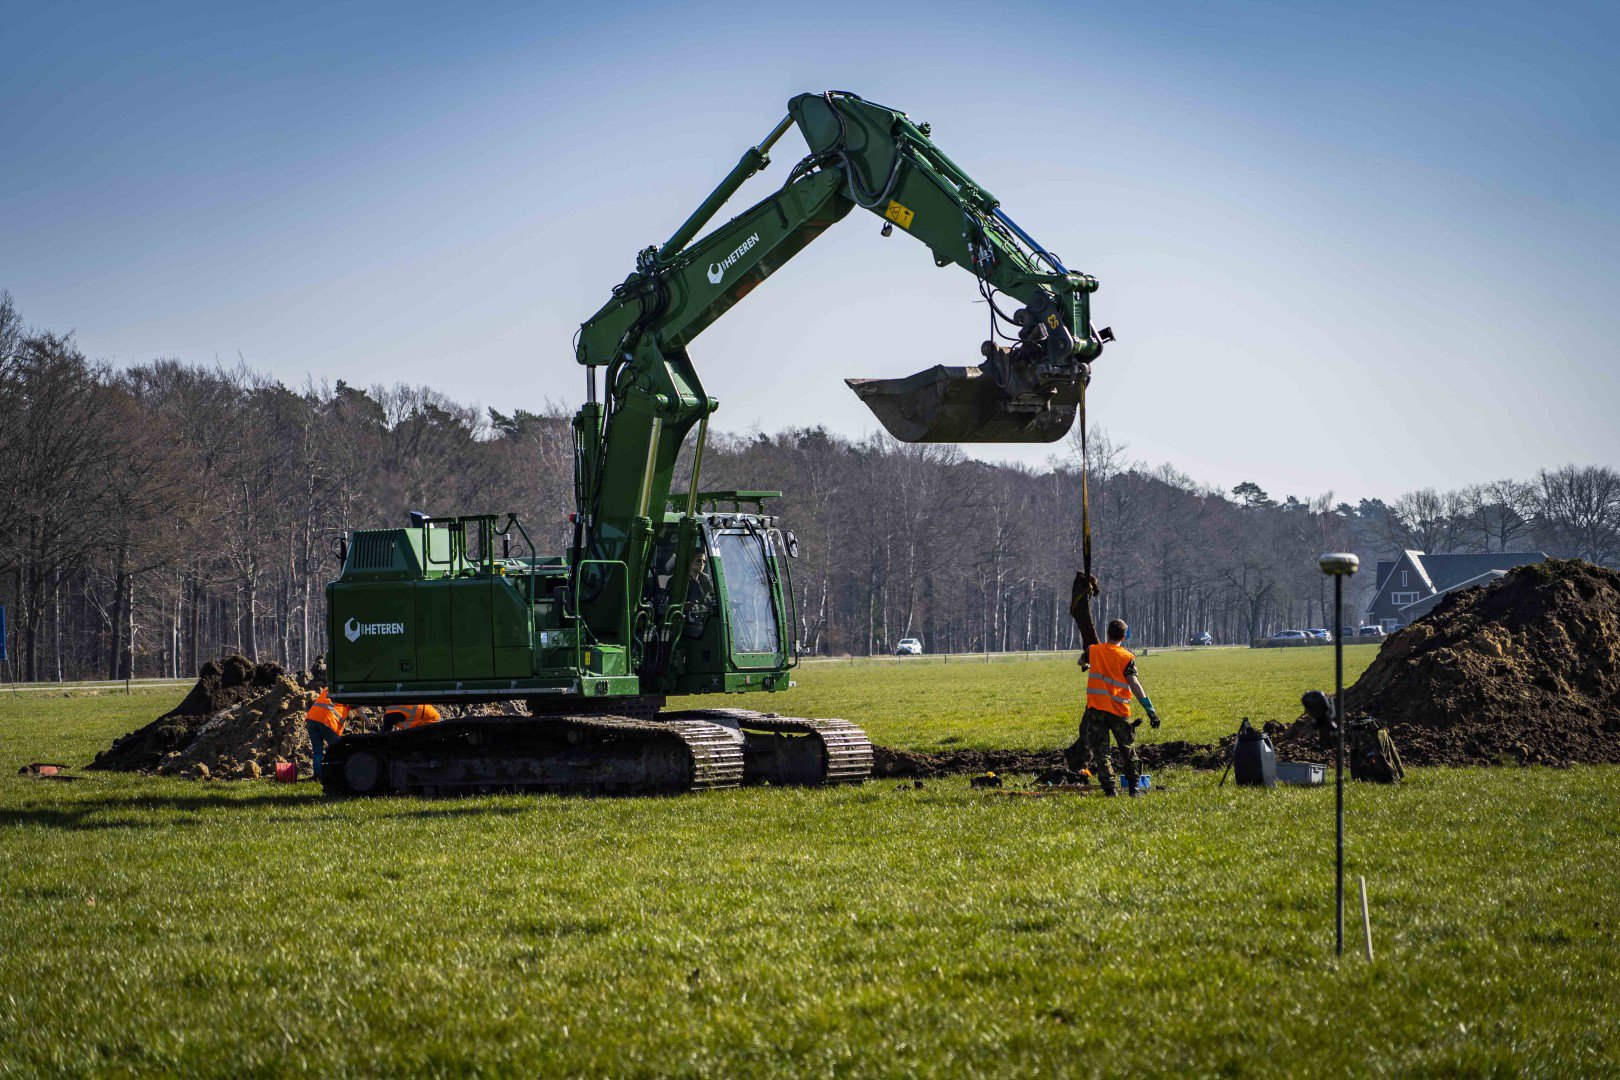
xmin=0 ymin=291 xmax=1620 ymax=680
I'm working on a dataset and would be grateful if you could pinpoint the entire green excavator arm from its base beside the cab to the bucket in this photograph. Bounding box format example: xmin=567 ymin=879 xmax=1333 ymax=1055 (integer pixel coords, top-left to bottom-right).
xmin=575 ymin=91 xmax=1111 ymax=634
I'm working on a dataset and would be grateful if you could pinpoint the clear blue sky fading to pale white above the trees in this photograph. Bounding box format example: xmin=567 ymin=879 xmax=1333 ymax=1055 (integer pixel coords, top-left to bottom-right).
xmin=0 ymin=0 xmax=1620 ymax=499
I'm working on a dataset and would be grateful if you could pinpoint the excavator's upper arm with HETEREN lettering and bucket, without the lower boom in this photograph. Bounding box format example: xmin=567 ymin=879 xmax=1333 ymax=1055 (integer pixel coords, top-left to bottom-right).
xmin=577 ymin=91 xmax=1111 ymax=442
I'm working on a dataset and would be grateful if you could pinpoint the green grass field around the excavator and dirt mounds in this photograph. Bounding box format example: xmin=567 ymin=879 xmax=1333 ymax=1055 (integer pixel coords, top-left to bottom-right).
xmin=0 ymin=651 xmax=1620 ymax=1075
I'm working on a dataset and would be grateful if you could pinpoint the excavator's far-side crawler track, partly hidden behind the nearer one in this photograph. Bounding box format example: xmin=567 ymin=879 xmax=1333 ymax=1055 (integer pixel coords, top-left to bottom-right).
xmin=664 ymin=709 xmax=872 ymax=787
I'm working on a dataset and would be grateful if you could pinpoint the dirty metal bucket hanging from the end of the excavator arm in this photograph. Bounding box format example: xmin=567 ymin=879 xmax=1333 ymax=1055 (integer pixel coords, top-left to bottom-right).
xmin=844 ymin=364 xmax=1081 ymax=442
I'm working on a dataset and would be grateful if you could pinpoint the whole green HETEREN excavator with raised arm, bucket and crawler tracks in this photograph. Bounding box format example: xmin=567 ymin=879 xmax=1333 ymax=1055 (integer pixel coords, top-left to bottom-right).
xmin=322 ymin=91 xmax=1111 ymax=795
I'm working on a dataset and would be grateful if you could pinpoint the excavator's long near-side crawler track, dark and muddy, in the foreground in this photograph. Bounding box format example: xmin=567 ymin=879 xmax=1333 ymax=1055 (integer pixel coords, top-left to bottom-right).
xmin=321 ymin=716 xmax=744 ymax=795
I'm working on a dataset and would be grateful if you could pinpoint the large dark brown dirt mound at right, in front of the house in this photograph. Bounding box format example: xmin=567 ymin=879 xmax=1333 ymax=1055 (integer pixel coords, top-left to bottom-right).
xmin=1275 ymin=559 xmax=1620 ymax=766
